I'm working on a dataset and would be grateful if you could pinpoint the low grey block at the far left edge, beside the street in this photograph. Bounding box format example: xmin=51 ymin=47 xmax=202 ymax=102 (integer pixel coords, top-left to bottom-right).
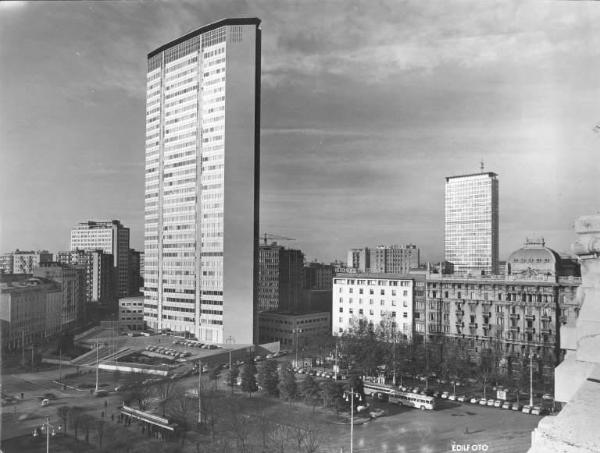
xmin=0 ymin=274 xmax=62 ymax=351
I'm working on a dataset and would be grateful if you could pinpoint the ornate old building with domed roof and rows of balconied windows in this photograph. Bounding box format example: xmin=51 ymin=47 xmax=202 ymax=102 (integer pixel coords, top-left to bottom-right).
xmin=426 ymin=240 xmax=581 ymax=375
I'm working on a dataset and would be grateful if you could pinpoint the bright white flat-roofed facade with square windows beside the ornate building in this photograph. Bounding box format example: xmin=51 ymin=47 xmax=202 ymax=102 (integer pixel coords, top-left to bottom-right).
xmin=331 ymin=274 xmax=414 ymax=338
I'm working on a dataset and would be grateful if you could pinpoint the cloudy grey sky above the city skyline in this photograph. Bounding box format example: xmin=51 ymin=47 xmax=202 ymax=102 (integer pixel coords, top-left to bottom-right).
xmin=0 ymin=0 xmax=600 ymax=262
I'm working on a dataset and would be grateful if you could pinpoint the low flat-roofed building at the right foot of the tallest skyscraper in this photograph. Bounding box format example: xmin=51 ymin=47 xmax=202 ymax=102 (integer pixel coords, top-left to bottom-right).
xmin=258 ymin=312 xmax=331 ymax=347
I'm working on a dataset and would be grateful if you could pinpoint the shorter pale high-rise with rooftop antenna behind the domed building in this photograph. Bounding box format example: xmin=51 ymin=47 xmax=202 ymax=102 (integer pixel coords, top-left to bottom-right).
xmin=445 ymin=172 xmax=498 ymax=274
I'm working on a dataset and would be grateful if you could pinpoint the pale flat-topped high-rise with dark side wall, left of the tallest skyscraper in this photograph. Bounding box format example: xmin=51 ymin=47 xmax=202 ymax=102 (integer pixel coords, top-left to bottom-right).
xmin=71 ymin=220 xmax=129 ymax=297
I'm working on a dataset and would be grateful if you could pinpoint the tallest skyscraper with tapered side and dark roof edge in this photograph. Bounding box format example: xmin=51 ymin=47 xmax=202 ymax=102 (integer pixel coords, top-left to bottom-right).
xmin=144 ymin=18 xmax=261 ymax=344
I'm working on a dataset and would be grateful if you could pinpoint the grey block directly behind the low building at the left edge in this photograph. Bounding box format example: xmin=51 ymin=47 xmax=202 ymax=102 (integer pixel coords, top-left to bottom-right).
xmin=33 ymin=262 xmax=85 ymax=329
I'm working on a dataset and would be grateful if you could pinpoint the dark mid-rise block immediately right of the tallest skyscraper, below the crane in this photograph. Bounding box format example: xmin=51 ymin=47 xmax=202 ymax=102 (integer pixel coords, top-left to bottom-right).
xmin=258 ymin=242 xmax=304 ymax=312
